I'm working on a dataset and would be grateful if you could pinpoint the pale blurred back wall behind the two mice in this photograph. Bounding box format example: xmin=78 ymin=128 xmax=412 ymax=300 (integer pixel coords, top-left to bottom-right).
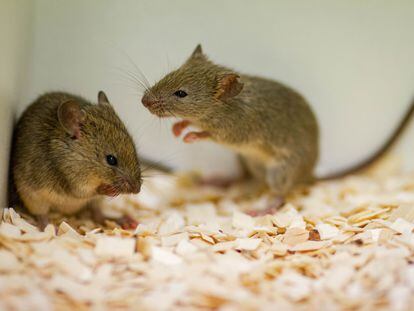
xmin=23 ymin=0 xmax=414 ymax=178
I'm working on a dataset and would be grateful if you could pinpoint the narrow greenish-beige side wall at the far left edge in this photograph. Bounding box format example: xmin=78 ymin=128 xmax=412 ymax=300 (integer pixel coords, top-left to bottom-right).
xmin=0 ymin=0 xmax=32 ymax=207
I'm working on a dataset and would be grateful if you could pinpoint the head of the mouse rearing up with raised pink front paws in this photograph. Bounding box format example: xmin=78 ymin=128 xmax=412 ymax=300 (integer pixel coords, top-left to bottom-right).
xmin=142 ymin=45 xmax=243 ymax=121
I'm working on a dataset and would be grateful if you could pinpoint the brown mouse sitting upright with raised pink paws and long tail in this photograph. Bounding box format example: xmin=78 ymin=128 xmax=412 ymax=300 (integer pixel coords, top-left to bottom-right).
xmin=141 ymin=45 xmax=414 ymax=214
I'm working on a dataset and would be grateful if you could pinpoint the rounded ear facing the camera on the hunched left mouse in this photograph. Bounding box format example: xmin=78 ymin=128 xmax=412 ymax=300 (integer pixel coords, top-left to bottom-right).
xmin=57 ymin=100 xmax=85 ymax=139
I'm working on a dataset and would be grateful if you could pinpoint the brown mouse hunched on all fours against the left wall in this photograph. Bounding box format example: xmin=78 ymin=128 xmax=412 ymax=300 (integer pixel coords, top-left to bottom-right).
xmin=11 ymin=91 xmax=142 ymax=229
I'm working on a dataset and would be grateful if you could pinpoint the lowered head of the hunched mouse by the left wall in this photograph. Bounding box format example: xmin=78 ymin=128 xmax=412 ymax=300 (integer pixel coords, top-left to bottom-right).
xmin=55 ymin=91 xmax=141 ymax=197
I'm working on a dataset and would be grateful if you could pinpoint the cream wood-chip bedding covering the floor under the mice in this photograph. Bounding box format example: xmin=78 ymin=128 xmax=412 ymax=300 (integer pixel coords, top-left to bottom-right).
xmin=0 ymin=168 xmax=414 ymax=310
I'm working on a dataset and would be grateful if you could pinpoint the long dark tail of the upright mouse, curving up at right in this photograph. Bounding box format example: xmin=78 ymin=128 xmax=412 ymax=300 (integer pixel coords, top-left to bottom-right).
xmin=317 ymin=101 xmax=414 ymax=181
